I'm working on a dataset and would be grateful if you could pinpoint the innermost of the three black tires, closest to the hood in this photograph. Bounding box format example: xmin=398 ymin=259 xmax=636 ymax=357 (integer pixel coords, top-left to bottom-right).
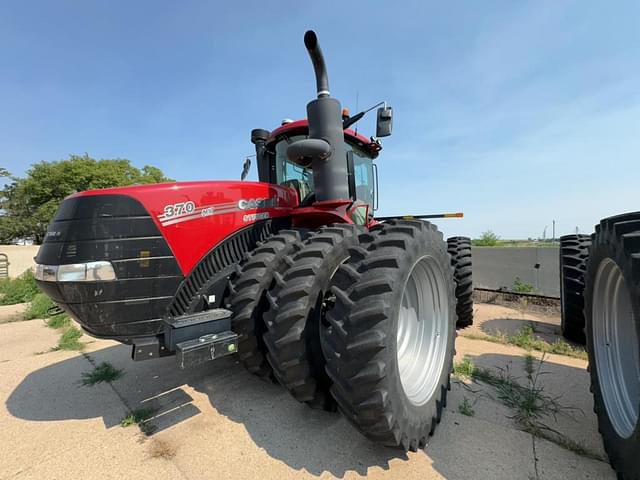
xmin=230 ymin=230 xmax=307 ymax=377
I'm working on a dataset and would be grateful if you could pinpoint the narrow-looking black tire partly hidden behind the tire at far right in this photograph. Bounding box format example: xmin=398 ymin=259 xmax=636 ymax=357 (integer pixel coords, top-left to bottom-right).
xmin=560 ymin=235 xmax=591 ymax=345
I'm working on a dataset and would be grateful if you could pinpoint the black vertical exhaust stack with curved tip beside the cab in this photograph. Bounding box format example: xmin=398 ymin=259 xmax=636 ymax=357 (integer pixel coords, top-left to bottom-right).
xmin=287 ymin=30 xmax=349 ymax=201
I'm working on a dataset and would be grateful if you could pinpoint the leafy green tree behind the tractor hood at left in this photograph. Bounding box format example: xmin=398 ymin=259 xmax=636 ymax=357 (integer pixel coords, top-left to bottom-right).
xmin=0 ymin=154 xmax=172 ymax=243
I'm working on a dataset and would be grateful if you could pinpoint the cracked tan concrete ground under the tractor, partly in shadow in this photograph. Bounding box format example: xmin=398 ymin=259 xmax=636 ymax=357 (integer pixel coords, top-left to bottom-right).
xmin=0 ymin=304 xmax=615 ymax=480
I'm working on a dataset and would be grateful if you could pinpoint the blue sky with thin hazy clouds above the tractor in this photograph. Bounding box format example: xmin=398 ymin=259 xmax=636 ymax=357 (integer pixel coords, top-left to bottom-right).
xmin=0 ymin=0 xmax=640 ymax=238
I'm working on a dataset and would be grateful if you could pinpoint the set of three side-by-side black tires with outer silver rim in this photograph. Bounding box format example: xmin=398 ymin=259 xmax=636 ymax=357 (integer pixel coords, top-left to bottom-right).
xmin=232 ymin=220 xmax=457 ymax=451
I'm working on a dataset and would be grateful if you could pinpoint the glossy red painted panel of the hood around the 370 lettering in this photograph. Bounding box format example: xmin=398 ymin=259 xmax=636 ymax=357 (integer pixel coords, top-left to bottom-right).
xmin=72 ymin=181 xmax=298 ymax=275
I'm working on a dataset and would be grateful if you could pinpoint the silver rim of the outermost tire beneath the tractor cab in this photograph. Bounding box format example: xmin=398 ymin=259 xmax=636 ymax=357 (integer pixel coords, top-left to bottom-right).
xmin=396 ymin=256 xmax=450 ymax=406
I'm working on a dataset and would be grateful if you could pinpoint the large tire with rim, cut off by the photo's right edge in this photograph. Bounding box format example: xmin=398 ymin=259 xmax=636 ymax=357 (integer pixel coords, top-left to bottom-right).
xmin=584 ymin=212 xmax=640 ymax=480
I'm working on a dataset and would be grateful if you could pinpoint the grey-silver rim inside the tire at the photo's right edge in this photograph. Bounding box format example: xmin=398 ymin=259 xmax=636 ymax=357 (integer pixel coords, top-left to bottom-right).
xmin=592 ymin=258 xmax=640 ymax=438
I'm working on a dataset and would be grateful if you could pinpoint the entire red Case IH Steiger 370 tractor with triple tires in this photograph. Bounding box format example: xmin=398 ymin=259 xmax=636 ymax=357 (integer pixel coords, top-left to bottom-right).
xmin=36 ymin=31 xmax=472 ymax=450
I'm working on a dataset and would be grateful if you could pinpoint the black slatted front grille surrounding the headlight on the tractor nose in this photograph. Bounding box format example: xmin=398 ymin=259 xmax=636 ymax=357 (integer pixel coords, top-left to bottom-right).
xmin=36 ymin=195 xmax=184 ymax=341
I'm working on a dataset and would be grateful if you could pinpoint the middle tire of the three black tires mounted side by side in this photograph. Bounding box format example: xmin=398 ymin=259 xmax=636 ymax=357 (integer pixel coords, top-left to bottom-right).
xmin=264 ymin=224 xmax=363 ymax=411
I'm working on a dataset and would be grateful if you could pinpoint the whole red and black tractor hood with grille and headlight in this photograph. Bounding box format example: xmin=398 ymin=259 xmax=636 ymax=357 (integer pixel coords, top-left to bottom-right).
xmin=36 ymin=181 xmax=298 ymax=343
